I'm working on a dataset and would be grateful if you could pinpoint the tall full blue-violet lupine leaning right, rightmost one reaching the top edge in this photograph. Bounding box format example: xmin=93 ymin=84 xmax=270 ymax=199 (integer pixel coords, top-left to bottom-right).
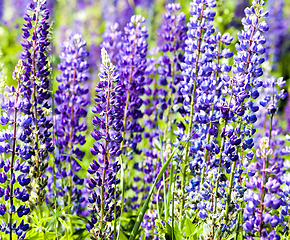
xmin=207 ymin=1 xmax=268 ymax=233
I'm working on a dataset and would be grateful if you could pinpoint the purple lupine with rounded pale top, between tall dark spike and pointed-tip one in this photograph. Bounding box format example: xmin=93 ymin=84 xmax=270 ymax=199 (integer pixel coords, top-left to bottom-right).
xmin=55 ymin=34 xmax=90 ymax=218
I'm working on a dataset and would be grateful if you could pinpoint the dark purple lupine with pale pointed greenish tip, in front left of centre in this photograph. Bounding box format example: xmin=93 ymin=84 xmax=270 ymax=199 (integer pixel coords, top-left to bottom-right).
xmin=86 ymin=48 xmax=124 ymax=239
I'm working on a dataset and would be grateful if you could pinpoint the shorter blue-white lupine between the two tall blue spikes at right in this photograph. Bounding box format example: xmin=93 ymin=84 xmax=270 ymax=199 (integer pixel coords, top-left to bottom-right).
xmin=193 ymin=33 xmax=233 ymax=183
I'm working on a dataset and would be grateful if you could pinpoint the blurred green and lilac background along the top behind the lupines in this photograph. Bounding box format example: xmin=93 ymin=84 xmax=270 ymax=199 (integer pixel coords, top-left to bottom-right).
xmin=0 ymin=0 xmax=290 ymax=84
